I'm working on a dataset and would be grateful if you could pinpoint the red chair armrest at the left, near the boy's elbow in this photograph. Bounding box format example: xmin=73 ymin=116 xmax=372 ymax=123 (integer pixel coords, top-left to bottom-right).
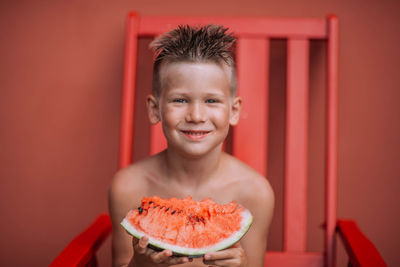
xmin=50 ymin=214 xmax=111 ymax=267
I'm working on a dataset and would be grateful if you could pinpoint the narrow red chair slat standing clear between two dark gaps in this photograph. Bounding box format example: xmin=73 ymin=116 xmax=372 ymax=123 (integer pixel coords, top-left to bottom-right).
xmin=283 ymin=39 xmax=309 ymax=252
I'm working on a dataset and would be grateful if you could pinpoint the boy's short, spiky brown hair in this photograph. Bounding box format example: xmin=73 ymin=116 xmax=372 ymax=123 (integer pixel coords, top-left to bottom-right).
xmin=150 ymin=24 xmax=237 ymax=96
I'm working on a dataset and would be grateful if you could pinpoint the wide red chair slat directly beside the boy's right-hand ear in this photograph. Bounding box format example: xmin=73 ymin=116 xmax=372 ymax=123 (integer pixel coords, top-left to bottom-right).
xmin=233 ymin=38 xmax=269 ymax=176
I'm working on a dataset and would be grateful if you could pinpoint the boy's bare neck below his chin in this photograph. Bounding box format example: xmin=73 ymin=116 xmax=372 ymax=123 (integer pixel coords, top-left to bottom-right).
xmin=164 ymin=147 xmax=223 ymax=186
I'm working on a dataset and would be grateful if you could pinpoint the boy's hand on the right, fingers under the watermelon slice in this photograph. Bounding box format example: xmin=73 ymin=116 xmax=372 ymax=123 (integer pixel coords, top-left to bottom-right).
xmin=203 ymin=242 xmax=247 ymax=267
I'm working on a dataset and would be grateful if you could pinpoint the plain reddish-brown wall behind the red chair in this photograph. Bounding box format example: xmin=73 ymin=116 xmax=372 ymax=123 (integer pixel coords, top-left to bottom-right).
xmin=0 ymin=0 xmax=400 ymax=266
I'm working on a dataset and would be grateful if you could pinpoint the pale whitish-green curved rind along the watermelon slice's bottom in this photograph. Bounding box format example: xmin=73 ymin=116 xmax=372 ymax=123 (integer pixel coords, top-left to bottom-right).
xmin=121 ymin=209 xmax=253 ymax=257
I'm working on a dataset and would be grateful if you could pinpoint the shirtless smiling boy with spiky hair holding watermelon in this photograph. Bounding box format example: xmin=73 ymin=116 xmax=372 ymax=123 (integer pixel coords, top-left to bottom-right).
xmin=109 ymin=25 xmax=274 ymax=267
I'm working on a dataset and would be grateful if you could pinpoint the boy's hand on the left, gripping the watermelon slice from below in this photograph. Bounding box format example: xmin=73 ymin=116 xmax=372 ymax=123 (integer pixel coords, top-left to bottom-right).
xmin=132 ymin=236 xmax=191 ymax=267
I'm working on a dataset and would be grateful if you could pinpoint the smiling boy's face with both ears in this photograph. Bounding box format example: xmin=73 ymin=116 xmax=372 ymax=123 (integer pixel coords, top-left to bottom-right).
xmin=148 ymin=62 xmax=241 ymax=157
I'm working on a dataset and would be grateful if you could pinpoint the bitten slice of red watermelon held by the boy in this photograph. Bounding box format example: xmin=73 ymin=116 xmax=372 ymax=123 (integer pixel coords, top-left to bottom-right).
xmin=121 ymin=196 xmax=253 ymax=256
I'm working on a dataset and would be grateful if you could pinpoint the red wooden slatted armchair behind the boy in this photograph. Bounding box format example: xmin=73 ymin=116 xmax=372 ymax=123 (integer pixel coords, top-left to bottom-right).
xmin=51 ymin=13 xmax=386 ymax=266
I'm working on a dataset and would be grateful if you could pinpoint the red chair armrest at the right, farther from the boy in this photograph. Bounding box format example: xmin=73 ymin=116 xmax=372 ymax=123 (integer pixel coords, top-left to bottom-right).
xmin=337 ymin=220 xmax=387 ymax=267
